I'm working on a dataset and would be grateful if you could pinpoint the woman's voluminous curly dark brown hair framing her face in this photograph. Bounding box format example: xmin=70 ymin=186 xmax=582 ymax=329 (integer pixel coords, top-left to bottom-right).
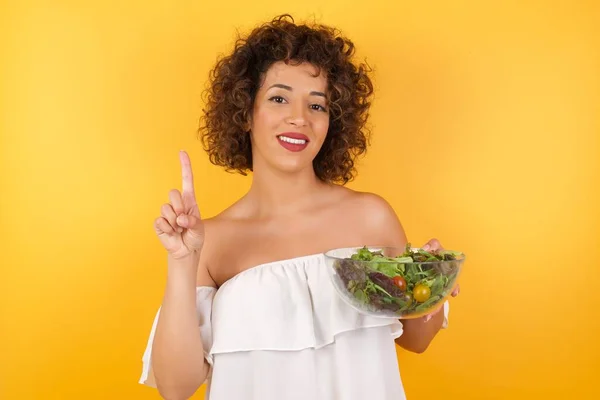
xmin=199 ymin=14 xmax=373 ymax=184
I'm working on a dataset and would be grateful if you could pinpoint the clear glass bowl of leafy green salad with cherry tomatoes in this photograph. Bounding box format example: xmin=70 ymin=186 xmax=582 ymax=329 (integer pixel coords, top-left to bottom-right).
xmin=335 ymin=243 xmax=464 ymax=316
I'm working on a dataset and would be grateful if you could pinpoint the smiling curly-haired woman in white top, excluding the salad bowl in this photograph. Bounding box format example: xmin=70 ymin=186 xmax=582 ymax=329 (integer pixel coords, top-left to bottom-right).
xmin=140 ymin=16 xmax=460 ymax=400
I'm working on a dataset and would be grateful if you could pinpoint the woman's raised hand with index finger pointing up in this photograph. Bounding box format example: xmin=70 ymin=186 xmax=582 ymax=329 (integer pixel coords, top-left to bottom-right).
xmin=154 ymin=151 xmax=204 ymax=259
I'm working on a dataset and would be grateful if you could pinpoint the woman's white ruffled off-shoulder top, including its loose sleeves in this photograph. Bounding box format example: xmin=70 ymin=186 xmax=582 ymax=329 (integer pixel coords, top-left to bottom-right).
xmin=139 ymin=254 xmax=448 ymax=400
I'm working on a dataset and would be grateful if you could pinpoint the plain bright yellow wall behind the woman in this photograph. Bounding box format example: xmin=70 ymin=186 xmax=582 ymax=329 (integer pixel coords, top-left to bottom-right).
xmin=0 ymin=0 xmax=600 ymax=400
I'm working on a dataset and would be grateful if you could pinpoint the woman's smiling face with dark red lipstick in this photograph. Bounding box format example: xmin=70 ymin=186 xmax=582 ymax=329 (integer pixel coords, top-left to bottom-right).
xmin=250 ymin=62 xmax=329 ymax=177
